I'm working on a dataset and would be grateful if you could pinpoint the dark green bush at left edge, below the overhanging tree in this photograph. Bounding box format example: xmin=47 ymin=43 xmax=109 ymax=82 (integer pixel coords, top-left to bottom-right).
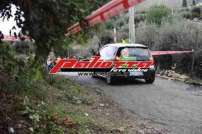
xmin=0 ymin=43 xmax=43 ymax=92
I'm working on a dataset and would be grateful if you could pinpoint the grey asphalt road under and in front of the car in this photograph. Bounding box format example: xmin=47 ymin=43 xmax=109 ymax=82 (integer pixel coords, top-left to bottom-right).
xmin=59 ymin=74 xmax=202 ymax=134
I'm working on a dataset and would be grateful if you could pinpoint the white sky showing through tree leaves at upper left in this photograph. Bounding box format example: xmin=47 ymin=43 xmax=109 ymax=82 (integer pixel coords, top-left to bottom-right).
xmin=0 ymin=5 xmax=20 ymax=35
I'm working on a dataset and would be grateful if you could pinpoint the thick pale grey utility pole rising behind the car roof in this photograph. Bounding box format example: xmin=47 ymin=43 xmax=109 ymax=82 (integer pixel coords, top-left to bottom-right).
xmin=129 ymin=7 xmax=135 ymax=43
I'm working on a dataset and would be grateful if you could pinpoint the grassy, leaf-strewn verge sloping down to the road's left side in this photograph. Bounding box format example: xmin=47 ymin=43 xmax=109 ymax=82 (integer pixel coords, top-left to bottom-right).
xmin=0 ymin=72 xmax=147 ymax=134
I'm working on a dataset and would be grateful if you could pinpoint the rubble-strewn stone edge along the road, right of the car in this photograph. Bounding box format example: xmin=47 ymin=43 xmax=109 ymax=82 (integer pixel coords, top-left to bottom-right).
xmin=156 ymin=74 xmax=202 ymax=86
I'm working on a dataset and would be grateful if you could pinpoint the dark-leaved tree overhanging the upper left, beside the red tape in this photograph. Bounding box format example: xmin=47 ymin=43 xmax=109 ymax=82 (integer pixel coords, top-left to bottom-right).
xmin=0 ymin=0 xmax=108 ymax=57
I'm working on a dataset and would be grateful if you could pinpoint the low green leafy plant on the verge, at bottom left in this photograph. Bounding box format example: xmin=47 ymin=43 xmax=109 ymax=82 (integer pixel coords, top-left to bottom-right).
xmin=22 ymin=97 xmax=64 ymax=134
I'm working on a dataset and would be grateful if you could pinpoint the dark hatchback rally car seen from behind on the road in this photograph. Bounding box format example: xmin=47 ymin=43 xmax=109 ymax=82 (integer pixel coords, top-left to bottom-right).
xmin=93 ymin=44 xmax=155 ymax=84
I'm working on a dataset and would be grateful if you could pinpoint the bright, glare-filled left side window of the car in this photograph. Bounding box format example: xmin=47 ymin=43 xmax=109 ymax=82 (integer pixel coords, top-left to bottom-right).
xmin=100 ymin=46 xmax=116 ymax=60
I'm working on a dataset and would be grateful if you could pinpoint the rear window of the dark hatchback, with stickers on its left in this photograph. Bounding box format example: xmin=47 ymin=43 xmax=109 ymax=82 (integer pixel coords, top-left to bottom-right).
xmin=119 ymin=47 xmax=150 ymax=61
